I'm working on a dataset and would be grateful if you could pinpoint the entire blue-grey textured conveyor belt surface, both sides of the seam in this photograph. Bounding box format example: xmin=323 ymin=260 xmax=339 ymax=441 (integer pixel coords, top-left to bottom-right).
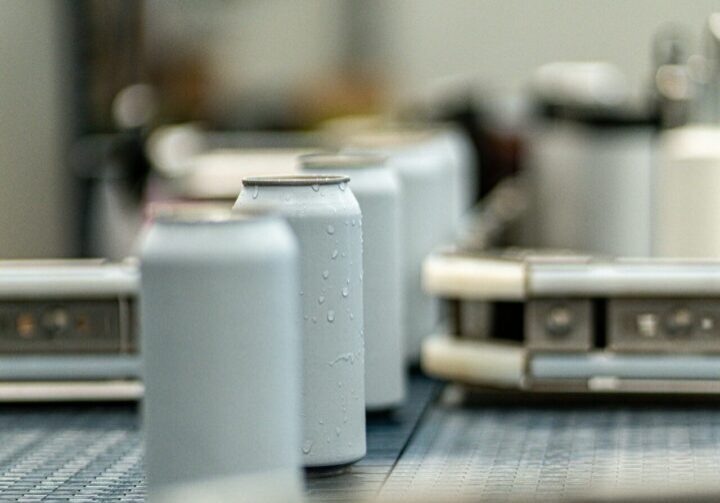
xmin=0 ymin=378 xmax=720 ymax=502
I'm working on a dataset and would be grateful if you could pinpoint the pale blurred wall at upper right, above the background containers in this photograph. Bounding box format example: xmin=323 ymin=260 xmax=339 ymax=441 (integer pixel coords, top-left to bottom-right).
xmin=382 ymin=0 xmax=720 ymax=100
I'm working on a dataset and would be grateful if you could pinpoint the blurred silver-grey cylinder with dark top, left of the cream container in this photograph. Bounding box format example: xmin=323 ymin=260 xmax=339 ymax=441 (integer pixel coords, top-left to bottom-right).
xmin=526 ymin=119 xmax=656 ymax=256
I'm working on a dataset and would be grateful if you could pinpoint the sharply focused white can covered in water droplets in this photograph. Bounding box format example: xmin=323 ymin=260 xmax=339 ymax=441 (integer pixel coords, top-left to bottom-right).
xmin=235 ymin=175 xmax=366 ymax=468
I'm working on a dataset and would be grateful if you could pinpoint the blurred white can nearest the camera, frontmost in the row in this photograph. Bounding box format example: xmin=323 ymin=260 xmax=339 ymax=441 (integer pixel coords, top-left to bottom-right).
xmin=141 ymin=208 xmax=302 ymax=502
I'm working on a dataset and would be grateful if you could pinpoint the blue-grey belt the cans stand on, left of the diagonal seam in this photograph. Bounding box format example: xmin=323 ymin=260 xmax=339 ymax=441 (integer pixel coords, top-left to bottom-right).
xmin=0 ymin=377 xmax=438 ymax=502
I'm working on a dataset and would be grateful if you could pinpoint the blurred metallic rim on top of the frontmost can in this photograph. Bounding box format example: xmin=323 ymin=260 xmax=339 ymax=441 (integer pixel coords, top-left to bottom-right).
xmin=148 ymin=202 xmax=273 ymax=223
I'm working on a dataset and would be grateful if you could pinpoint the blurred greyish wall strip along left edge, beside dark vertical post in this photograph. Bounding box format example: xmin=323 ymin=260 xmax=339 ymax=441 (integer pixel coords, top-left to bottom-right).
xmin=0 ymin=0 xmax=75 ymax=258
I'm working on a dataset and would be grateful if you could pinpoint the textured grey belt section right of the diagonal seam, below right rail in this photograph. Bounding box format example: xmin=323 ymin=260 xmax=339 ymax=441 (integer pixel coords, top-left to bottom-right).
xmin=382 ymin=392 xmax=720 ymax=501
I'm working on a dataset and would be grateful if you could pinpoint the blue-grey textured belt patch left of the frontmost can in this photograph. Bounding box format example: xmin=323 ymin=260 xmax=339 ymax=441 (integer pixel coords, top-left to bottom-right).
xmin=0 ymin=406 xmax=144 ymax=502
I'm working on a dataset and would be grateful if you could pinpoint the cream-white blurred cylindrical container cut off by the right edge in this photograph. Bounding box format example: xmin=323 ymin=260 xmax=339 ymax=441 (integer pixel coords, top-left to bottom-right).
xmin=653 ymin=126 xmax=720 ymax=257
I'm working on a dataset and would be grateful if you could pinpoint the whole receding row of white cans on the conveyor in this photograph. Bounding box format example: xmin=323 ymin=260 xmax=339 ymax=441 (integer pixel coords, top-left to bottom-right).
xmin=141 ymin=127 xmax=472 ymax=500
